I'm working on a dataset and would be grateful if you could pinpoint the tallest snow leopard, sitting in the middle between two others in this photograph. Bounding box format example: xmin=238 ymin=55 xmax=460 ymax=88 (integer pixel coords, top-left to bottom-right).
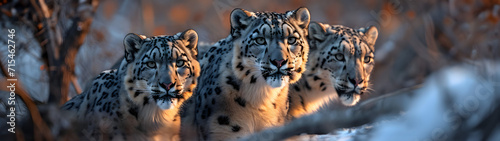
xmin=181 ymin=8 xmax=310 ymax=140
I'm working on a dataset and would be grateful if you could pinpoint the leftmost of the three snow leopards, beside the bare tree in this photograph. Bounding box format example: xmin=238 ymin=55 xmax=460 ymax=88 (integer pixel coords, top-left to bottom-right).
xmin=62 ymin=30 xmax=200 ymax=140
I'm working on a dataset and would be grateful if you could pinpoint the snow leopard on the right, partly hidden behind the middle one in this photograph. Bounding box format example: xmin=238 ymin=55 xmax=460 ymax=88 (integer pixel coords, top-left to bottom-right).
xmin=289 ymin=22 xmax=378 ymax=117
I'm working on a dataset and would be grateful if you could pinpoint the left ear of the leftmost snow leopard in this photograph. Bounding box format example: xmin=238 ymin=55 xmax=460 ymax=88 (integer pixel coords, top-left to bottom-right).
xmin=123 ymin=33 xmax=146 ymax=63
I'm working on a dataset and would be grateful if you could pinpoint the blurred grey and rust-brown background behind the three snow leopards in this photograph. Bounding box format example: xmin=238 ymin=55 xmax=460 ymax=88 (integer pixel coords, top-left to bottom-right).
xmin=0 ymin=0 xmax=500 ymax=140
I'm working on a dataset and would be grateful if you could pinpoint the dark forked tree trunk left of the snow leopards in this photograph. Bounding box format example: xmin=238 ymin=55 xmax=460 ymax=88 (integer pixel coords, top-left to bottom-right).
xmin=31 ymin=0 xmax=98 ymax=105
